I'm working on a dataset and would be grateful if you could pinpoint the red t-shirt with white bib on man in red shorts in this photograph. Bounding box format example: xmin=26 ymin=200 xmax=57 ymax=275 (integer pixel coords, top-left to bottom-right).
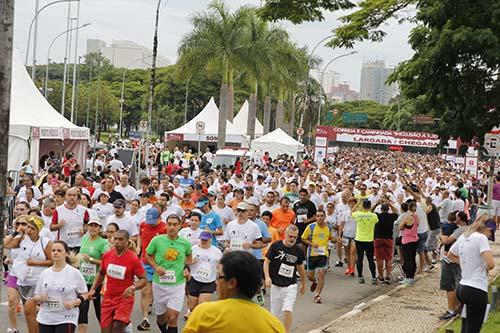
xmin=101 ymin=248 xmax=145 ymax=296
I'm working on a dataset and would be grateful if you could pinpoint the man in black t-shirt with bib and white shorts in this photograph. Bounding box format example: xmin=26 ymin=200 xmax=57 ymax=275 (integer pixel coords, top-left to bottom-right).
xmin=264 ymin=225 xmax=306 ymax=332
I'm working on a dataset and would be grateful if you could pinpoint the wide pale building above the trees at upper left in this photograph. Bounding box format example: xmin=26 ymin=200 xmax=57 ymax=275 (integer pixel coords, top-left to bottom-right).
xmin=87 ymin=39 xmax=170 ymax=69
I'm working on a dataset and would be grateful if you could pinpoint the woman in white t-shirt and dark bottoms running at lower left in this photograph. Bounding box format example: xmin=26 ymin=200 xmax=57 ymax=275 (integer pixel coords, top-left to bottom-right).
xmin=33 ymin=241 xmax=88 ymax=333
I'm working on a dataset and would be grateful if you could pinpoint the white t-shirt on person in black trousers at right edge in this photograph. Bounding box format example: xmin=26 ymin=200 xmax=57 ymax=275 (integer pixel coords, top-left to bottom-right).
xmin=450 ymin=232 xmax=491 ymax=292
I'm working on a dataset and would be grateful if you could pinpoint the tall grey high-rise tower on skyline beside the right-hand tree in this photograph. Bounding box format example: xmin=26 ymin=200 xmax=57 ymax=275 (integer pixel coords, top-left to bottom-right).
xmin=359 ymin=60 xmax=397 ymax=104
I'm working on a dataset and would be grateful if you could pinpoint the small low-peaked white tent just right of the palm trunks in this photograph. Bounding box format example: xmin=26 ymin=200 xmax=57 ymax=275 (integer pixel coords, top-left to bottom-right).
xmin=252 ymin=128 xmax=304 ymax=158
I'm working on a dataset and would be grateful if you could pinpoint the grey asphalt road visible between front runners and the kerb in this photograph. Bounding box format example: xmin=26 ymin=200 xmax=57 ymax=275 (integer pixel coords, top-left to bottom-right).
xmin=0 ymin=256 xmax=395 ymax=333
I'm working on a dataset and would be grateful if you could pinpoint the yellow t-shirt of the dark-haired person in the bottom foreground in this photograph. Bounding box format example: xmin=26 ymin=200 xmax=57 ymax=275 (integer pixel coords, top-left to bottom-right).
xmin=182 ymin=298 xmax=285 ymax=333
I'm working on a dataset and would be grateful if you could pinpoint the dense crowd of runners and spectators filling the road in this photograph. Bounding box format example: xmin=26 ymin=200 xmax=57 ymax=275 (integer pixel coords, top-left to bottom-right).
xmin=3 ymin=147 xmax=500 ymax=333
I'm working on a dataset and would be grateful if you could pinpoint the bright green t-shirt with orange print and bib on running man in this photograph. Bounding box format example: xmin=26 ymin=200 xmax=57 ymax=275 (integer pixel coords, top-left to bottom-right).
xmin=146 ymin=235 xmax=191 ymax=286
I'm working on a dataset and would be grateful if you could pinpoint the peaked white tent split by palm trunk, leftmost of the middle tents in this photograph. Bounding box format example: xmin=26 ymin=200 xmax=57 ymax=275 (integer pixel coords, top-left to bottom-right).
xmin=165 ymin=97 xmax=248 ymax=147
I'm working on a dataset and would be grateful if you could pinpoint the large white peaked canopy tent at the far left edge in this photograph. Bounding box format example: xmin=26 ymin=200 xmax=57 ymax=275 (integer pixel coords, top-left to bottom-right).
xmin=8 ymin=52 xmax=90 ymax=172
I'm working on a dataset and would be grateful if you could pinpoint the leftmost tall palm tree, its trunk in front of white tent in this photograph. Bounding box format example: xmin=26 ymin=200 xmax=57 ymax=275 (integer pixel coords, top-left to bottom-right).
xmin=178 ymin=0 xmax=250 ymax=148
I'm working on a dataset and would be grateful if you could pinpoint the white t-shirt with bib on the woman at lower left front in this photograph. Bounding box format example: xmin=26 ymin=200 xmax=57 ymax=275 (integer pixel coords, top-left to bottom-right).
xmin=35 ymin=265 xmax=87 ymax=325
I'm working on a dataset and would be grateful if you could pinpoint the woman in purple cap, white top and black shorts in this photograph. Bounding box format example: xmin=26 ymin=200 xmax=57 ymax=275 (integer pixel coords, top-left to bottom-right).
xmin=187 ymin=231 xmax=222 ymax=311
